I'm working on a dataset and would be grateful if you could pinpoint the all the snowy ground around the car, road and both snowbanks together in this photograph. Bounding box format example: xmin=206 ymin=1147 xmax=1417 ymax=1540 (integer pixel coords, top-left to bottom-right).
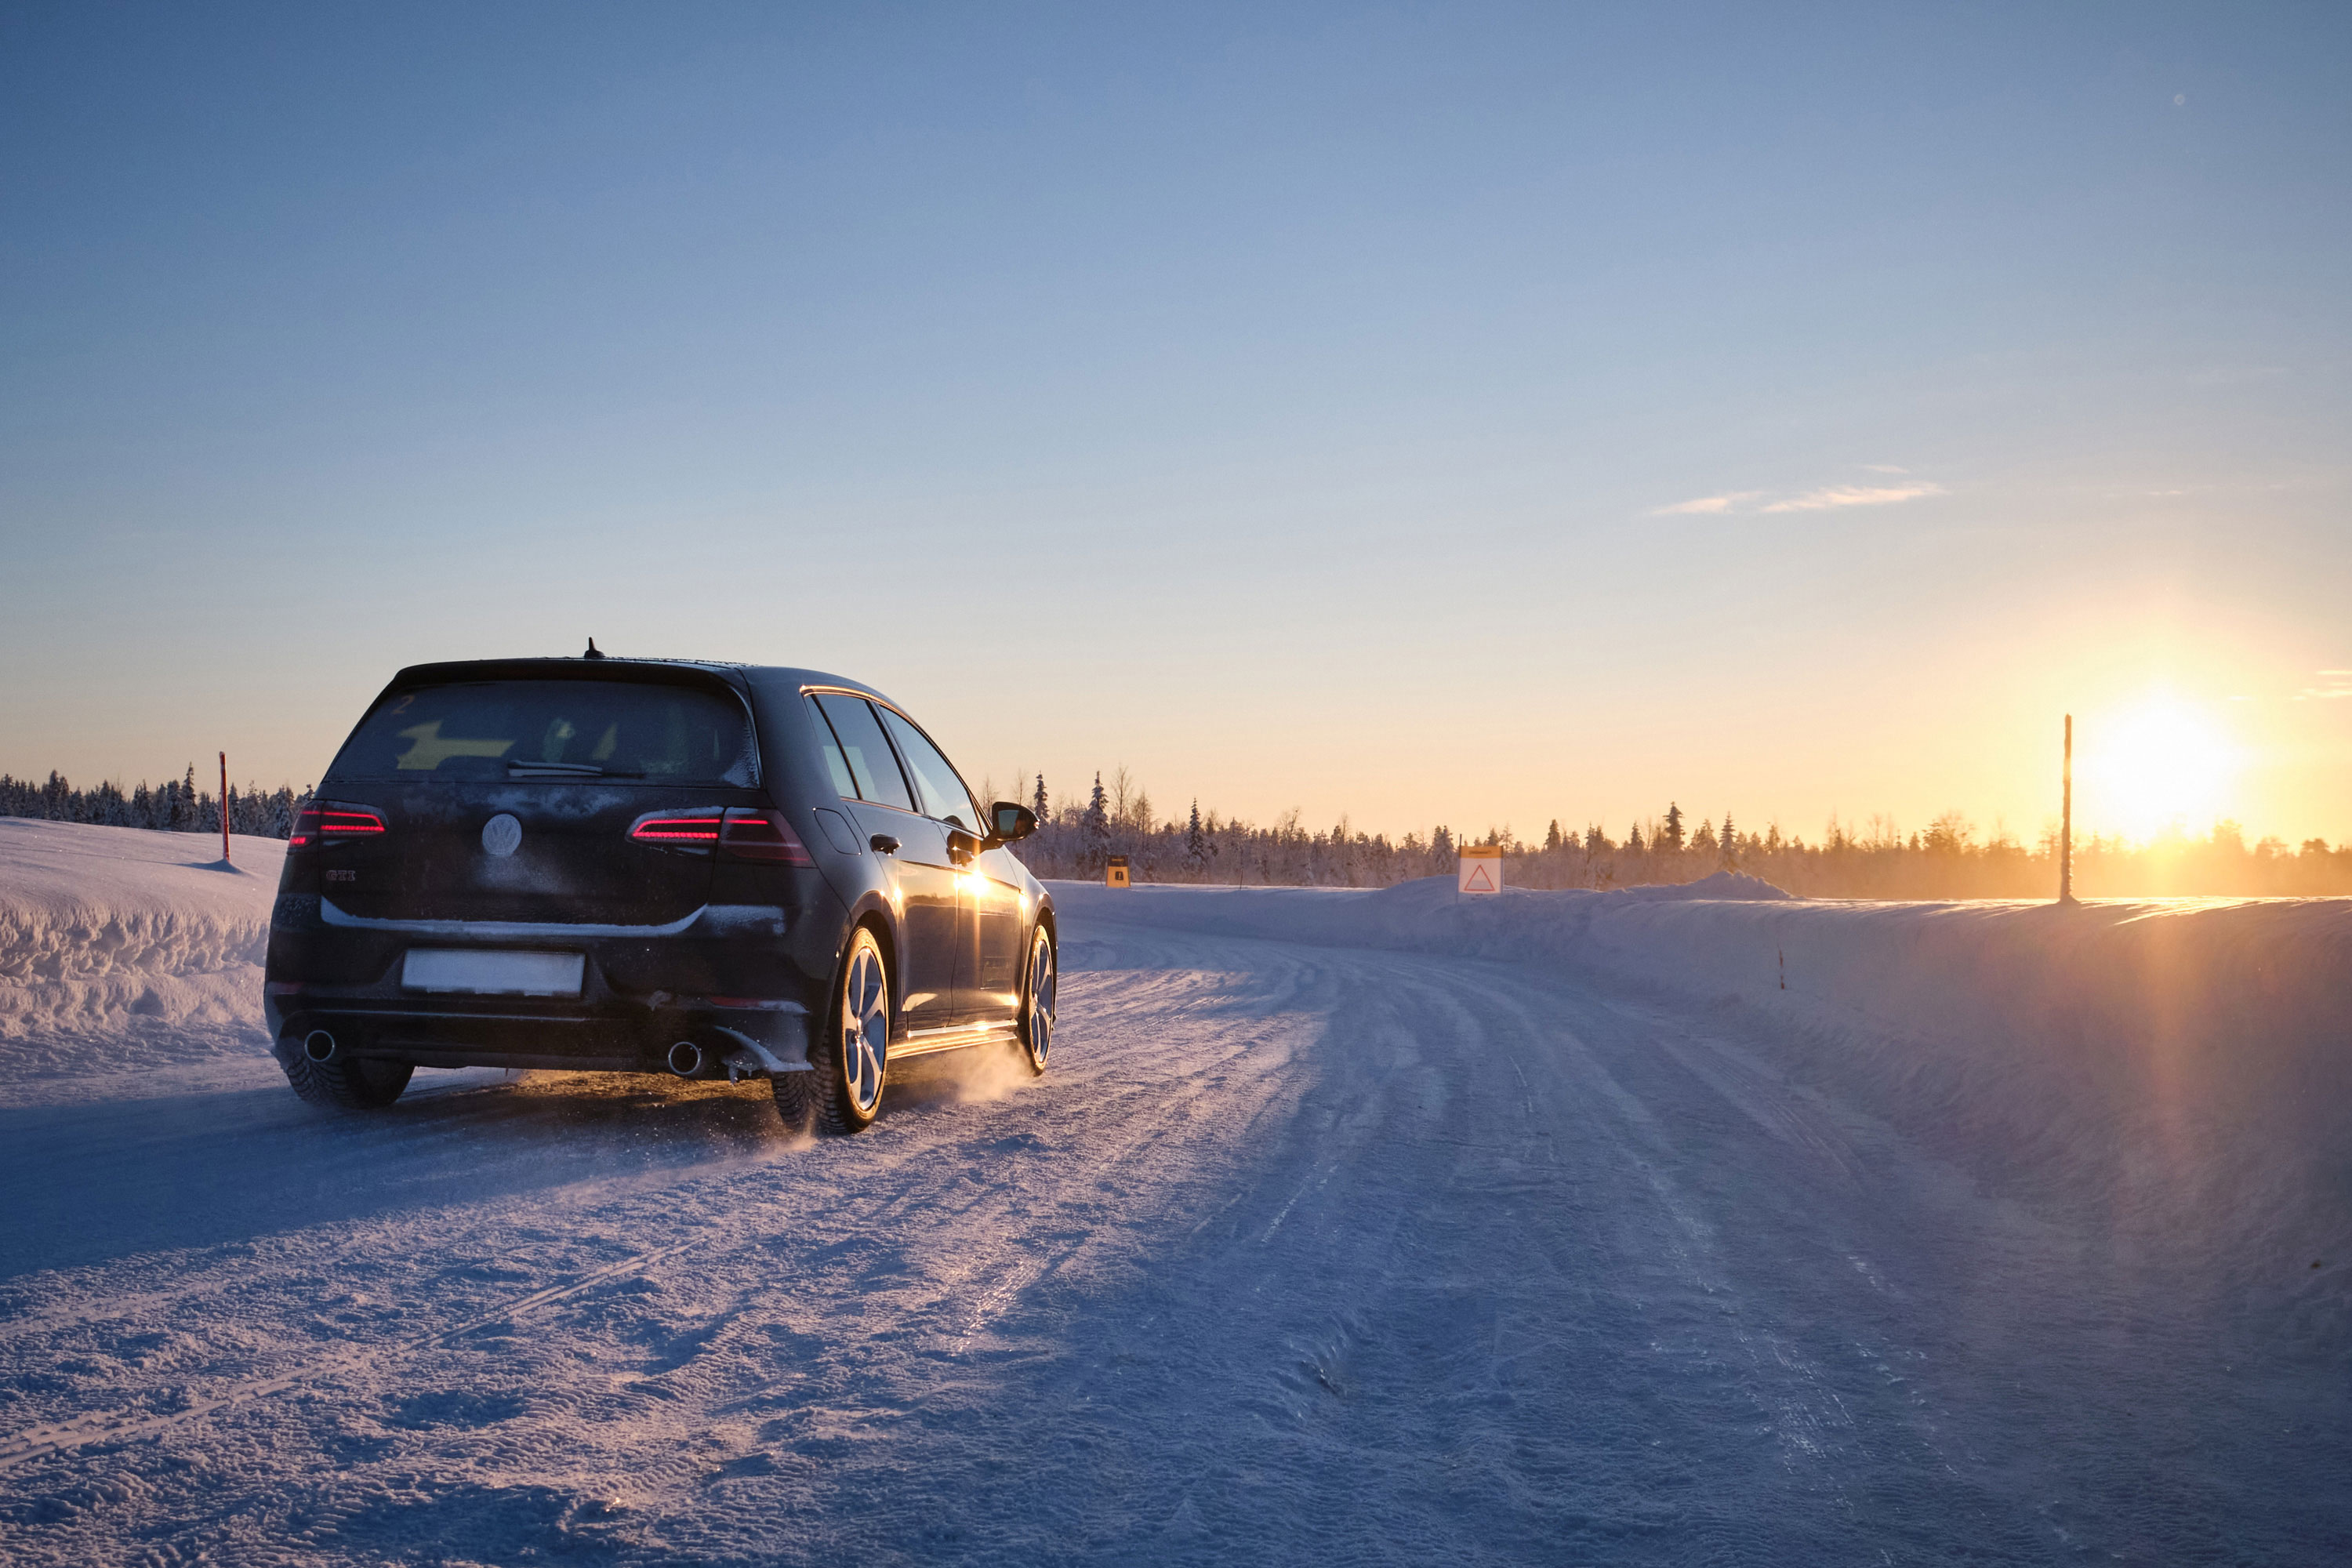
xmin=0 ymin=820 xmax=2352 ymax=1566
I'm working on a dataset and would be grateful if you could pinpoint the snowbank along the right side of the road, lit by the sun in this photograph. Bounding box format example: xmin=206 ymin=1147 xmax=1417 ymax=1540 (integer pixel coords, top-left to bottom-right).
xmin=1054 ymin=877 xmax=2352 ymax=1316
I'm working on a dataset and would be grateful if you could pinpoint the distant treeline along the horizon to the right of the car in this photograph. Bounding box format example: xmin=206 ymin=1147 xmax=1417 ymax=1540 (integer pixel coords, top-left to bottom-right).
xmin=1014 ymin=769 xmax=2352 ymax=898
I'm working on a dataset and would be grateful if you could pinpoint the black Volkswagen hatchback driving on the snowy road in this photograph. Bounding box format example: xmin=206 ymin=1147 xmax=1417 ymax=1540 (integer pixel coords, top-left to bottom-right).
xmin=263 ymin=644 xmax=1056 ymax=1131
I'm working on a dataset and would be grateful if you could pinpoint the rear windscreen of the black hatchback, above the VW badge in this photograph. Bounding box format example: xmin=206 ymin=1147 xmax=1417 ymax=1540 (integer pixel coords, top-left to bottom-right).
xmin=327 ymin=680 xmax=757 ymax=785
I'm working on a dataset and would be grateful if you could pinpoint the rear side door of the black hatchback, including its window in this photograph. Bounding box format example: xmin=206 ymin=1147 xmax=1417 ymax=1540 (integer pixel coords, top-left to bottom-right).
xmin=809 ymin=691 xmax=969 ymax=1034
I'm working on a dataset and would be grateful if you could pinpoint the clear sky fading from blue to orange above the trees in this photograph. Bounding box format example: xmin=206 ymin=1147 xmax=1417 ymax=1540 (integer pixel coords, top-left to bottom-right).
xmin=0 ymin=5 xmax=2352 ymax=839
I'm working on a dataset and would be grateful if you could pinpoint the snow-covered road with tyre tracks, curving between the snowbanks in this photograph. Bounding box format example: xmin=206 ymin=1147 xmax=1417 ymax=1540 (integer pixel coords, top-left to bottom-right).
xmin=0 ymin=898 xmax=2352 ymax=1563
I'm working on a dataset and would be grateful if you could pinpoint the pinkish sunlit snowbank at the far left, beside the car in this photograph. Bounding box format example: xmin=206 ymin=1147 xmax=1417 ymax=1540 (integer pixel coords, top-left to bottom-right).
xmin=0 ymin=818 xmax=285 ymax=1079
